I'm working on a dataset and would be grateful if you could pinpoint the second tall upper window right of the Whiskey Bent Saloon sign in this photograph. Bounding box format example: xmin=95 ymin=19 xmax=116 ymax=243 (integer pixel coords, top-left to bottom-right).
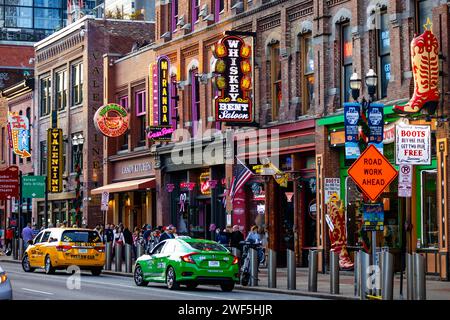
xmin=300 ymin=33 xmax=314 ymax=114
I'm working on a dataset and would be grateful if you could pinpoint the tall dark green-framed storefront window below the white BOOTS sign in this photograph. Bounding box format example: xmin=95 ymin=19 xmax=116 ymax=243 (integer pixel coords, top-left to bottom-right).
xmin=421 ymin=170 xmax=439 ymax=248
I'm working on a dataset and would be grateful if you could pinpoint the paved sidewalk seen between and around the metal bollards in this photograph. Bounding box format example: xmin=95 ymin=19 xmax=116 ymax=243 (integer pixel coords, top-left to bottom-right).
xmin=0 ymin=252 xmax=450 ymax=300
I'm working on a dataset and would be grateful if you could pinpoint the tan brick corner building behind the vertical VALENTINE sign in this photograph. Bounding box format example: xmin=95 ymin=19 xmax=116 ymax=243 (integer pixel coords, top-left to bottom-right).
xmin=33 ymin=17 xmax=154 ymax=227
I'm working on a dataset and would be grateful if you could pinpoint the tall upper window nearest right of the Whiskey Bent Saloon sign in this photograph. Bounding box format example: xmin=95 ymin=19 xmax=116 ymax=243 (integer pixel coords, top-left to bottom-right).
xmin=270 ymin=42 xmax=282 ymax=121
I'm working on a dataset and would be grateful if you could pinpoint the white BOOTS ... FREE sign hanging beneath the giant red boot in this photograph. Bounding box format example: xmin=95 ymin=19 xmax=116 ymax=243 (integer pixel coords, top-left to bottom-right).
xmin=395 ymin=125 xmax=431 ymax=165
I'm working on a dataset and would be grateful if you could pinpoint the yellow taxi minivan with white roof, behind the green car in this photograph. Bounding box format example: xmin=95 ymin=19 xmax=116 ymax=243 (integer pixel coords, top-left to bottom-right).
xmin=22 ymin=228 xmax=105 ymax=276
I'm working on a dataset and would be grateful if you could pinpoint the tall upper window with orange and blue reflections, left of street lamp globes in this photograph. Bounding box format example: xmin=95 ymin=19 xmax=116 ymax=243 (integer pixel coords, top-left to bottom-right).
xmin=341 ymin=23 xmax=353 ymax=103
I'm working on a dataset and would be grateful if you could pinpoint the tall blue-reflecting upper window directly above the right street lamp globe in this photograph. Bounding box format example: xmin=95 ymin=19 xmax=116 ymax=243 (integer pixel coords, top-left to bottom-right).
xmin=377 ymin=11 xmax=391 ymax=99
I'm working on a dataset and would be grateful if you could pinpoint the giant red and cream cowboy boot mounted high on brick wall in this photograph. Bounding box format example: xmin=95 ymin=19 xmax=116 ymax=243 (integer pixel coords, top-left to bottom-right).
xmin=394 ymin=19 xmax=439 ymax=114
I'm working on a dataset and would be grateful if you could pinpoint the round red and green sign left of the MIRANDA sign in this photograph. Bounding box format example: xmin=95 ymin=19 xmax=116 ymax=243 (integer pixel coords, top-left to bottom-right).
xmin=94 ymin=103 xmax=129 ymax=138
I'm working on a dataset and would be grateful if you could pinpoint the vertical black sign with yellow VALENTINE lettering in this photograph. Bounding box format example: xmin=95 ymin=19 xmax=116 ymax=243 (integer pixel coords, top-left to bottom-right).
xmin=47 ymin=128 xmax=63 ymax=193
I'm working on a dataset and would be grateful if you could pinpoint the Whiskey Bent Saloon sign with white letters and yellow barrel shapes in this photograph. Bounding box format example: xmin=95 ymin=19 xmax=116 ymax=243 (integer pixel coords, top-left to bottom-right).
xmin=212 ymin=36 xmax=253 ymax=123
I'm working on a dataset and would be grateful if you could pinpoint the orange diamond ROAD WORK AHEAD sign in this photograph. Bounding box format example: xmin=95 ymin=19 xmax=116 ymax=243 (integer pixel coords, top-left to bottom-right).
xmin=348 ymin=144 xmax=398 ymax=201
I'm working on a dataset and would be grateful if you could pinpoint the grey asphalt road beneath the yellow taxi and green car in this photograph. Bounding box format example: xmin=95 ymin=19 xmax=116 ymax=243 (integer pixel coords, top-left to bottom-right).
xmin=2 ymin=263 xmax=319 ymax=301
